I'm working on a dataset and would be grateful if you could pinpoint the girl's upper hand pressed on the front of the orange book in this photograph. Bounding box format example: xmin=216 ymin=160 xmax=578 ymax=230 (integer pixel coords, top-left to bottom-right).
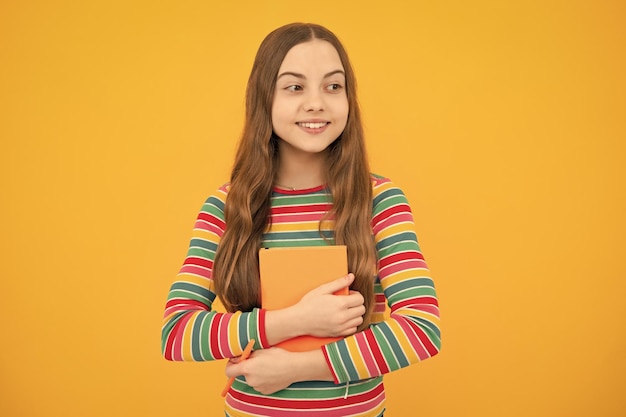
xmin=293 ymin=274 xmax=365 ymax=337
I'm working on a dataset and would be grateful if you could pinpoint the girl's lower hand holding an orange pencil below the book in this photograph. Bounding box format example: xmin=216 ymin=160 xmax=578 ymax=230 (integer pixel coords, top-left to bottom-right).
xmin=226 ymin=348 xmax=296 ymax=395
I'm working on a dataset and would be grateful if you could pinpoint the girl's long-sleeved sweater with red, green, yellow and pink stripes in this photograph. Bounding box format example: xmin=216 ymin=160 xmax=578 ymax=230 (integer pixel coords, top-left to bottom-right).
xmin=162 ymin=176 xmax=441 ymax=417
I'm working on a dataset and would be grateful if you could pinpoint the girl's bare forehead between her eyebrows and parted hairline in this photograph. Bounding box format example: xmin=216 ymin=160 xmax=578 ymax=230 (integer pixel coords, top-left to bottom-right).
xmin=278 ymin=39 xmax=344 ymax=74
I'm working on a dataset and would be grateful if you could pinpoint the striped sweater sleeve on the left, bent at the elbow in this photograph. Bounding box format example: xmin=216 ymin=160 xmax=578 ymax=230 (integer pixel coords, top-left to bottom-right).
xmin=161 ymin=186 xmax=269 ymax=361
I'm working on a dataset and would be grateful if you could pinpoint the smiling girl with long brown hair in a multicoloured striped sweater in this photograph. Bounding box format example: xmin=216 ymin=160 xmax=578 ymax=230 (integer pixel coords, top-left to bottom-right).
xmin=162 ymin=23 xmax=440 ymax=416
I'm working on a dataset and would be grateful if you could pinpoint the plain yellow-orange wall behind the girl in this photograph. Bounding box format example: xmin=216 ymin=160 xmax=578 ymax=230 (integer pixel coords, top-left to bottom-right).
xmin=0 ymin=0 xmax=626 ymax=417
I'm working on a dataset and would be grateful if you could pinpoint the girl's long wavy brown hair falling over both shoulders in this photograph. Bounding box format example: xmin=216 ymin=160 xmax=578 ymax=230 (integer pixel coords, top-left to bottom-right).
xmin=213 ymin=23 xmax=376 ymax=329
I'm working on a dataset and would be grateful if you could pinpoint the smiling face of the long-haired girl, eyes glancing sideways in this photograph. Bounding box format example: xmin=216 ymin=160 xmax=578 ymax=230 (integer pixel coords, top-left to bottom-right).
xmin=272 ymin=39 xmax=348 ymax=154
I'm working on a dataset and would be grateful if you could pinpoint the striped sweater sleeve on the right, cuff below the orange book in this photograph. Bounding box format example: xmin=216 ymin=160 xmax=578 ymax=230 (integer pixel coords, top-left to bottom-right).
xmin=322 ymin=178 xmax=441 ymax=383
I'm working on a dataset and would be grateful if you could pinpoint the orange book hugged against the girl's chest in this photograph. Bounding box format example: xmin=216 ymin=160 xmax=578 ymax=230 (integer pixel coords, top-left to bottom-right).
xmin=259 ymin=245 xmax=349 ymax=352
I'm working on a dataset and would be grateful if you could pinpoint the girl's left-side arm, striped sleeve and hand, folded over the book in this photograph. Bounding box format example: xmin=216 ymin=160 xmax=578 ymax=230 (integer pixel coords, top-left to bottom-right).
xmin=161 ymin=187 xmax=356 ymax=361
